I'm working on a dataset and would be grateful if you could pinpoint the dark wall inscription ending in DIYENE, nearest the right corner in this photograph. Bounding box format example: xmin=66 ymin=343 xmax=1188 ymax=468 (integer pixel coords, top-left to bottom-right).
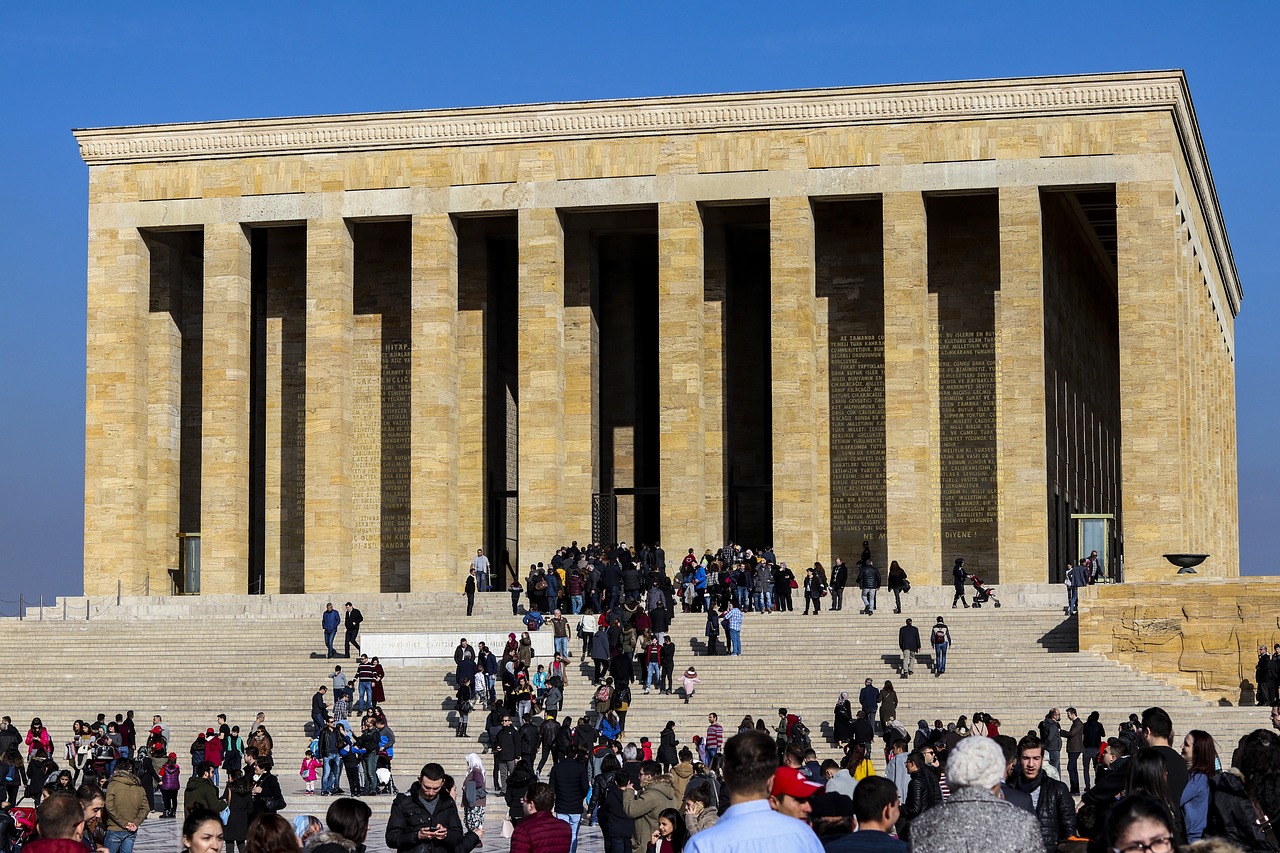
xmin=938 ymin=330 xmax=998 ymax=580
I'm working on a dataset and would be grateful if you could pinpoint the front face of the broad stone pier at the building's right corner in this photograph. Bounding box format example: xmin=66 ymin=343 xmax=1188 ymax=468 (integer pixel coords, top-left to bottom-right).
xmin=1116 ymin=181 xmax=1190 ymax=580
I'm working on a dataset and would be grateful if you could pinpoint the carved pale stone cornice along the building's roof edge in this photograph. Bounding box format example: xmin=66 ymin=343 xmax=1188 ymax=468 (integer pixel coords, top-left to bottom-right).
xmin=67 ymin=70 xmax=1240 ymax=308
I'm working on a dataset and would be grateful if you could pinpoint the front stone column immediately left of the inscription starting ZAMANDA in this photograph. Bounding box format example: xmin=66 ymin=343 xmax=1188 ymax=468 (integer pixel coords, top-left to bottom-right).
xmin=769 ymin=196 xmax=829 ymax=566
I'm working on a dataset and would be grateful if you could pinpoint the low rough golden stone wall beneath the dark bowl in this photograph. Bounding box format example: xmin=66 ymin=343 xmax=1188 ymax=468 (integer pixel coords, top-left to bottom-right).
xmin=1079 ymin=578 xmax=1280 ymax=704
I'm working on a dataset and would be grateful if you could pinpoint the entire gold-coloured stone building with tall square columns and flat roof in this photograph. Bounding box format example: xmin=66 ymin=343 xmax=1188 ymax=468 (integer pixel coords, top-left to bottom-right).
xmin=78 ymin=72 xmax=1240 ymax=593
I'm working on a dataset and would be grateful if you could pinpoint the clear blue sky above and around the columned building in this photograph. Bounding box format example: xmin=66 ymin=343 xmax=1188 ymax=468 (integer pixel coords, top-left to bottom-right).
xmin=0 ymin=0 xmax=1280 ymax=604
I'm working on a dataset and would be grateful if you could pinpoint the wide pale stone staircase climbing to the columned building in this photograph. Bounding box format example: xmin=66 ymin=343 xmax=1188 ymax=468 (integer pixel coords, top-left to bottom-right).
xmin=0 ymin=587 xmax=1267 ymax=795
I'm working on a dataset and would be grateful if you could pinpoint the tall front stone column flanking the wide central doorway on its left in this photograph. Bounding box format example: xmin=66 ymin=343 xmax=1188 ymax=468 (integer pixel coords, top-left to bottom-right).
xmin=516 ymin=207 xmax=564 ymax=563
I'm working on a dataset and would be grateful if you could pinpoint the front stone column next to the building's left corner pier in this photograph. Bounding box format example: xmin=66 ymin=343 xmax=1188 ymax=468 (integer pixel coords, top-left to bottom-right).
xmin=200 ymin=222 xmax=251 ymax=594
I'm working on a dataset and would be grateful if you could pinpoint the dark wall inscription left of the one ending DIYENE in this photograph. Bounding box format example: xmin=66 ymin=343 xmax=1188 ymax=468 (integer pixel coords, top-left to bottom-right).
xmin=828 ymin=334 xmax=886 ymax=562
